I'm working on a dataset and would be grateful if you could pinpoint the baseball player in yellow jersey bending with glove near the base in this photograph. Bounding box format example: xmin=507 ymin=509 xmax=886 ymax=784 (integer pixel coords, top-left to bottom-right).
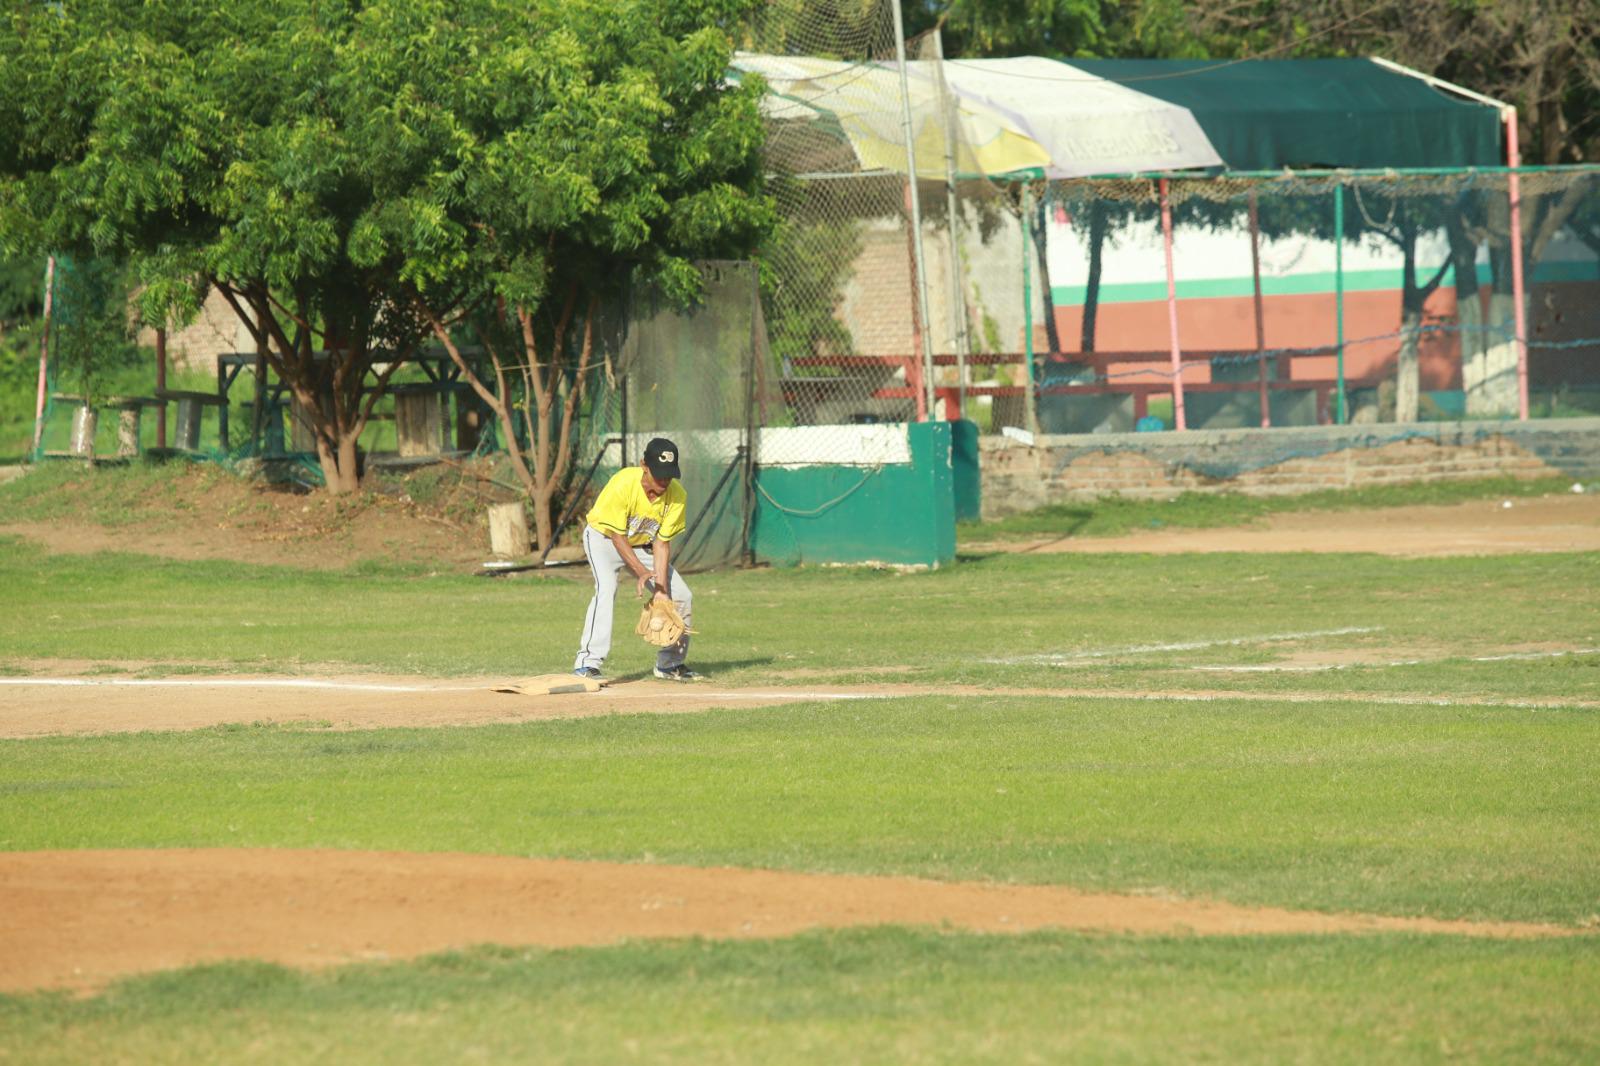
xmin=573 ymin=437 xmax=701 ymax=682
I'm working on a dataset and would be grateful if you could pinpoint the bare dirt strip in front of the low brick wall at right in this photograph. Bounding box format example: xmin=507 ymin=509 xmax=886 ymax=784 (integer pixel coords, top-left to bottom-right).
xmin=962 ymin=493 xmax=1600 ymax=557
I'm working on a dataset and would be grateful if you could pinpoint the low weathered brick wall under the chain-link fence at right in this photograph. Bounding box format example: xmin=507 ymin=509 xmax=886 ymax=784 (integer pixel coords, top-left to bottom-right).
xmin=979 ymin=418 xmax=1600 ymax=519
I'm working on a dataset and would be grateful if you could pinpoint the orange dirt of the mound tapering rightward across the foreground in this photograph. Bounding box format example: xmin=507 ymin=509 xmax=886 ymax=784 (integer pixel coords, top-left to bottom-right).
xmin=0 ymin=848 xmax=1574 ymax=991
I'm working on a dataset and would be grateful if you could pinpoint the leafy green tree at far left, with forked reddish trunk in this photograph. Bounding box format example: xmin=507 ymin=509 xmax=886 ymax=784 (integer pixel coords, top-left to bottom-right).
xmin=0 ymin=0 xmax=419 ymax=491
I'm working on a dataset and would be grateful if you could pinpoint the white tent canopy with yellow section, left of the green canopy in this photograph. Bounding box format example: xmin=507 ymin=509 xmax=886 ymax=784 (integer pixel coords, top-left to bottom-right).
xmin=733 ymin=53 xmax=1222 ymax=179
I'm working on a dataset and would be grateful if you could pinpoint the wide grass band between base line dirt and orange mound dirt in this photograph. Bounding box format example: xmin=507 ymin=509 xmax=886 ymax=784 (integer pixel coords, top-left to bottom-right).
xmin=0 ymin=696 xmax=1600 ymax=924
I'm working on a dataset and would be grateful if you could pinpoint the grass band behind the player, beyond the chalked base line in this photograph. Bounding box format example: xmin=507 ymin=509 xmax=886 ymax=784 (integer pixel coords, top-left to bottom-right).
xmin=0 ymin=539 xmax=1600 ymax=699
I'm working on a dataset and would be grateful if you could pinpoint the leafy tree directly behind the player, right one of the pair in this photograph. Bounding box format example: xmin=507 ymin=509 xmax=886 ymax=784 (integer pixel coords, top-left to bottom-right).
xmin=349 ymin=0 xmax=773 ymax=546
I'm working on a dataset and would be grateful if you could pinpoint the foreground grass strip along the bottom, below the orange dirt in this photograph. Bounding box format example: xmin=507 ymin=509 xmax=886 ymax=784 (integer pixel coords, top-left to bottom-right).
xmin=0 ymin=930 xmax=1600 ymax=1064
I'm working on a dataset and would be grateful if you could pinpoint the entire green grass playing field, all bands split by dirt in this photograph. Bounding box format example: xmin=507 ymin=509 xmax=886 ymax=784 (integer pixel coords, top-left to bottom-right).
xmin=0 ymin=476 xmax=1600 ymax=1063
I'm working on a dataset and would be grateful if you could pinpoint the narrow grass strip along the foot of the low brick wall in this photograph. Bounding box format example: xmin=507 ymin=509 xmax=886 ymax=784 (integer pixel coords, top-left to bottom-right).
xmin=955 ymin=477 xmax=1573 ymax=543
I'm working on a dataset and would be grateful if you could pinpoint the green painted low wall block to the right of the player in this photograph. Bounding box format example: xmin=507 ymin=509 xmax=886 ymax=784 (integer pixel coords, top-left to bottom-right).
xmin=750 ymin=423 xmax=953 ymax=568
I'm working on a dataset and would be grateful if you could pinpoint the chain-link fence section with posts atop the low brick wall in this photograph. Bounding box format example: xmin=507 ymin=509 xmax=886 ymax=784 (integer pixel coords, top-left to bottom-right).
xmin=1032 ymin=168 xmax=1600 ymax=432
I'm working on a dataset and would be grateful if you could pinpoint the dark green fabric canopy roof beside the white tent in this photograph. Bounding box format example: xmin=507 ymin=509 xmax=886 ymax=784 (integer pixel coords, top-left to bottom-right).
xmin=1066 ymin=59 xmax=1506 ymax=170
